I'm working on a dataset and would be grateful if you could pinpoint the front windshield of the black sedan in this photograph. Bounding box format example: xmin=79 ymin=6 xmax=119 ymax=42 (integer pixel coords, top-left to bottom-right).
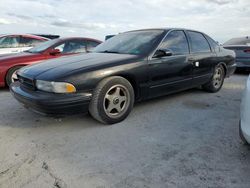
xmin=94 ymin=30 xmax=164 ymax=55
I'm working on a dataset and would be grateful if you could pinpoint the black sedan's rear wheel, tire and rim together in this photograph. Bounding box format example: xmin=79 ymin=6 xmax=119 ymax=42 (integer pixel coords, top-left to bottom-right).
xmin=202 ymin=65 xmax=226 ymax=93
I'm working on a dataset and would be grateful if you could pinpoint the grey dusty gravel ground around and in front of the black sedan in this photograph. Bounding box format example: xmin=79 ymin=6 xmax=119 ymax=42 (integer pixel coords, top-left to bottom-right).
xmin=0 ymin=74 xmax=250 ymax=188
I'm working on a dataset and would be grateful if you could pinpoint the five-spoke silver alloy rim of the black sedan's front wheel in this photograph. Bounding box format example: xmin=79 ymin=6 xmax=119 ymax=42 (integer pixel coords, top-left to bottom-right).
xmin=103 ymin=85 xmax=131 ymax=117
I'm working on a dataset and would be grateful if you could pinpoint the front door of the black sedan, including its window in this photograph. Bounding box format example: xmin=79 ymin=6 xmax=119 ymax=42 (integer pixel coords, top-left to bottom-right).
xmin=149 ymin=30 xmax=193 ymax=97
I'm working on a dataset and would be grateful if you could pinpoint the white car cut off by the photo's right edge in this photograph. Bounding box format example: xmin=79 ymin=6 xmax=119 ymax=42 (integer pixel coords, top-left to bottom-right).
xmin=239 ymin=76 xmax=250 ymax=144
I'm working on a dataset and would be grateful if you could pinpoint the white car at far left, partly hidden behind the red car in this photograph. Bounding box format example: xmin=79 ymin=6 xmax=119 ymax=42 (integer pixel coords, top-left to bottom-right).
xmin=0 ymin=34 xmax=49 ymax=55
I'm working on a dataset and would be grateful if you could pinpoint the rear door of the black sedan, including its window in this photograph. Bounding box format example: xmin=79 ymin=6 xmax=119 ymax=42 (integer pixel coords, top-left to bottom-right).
xmin=186 ymin=31 xmax=217 ymax=85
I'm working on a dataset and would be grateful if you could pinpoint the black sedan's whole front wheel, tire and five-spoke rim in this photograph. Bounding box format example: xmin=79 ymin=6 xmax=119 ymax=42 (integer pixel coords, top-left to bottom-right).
xmin=89 ymin=76 xmax=135 ymax=124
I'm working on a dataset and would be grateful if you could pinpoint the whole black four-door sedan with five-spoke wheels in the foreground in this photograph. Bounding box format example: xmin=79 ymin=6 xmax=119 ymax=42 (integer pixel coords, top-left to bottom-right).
xmin=10 ymin=29 xmax=236 ymax=124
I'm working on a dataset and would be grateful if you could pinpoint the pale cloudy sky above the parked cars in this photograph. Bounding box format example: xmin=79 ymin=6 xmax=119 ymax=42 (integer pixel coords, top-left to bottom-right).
xmin=0 ymin=0 xmax=250 ymax=42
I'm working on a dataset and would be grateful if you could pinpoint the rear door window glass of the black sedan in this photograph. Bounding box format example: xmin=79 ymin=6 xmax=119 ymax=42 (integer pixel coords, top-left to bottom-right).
xmin=188 ymin=31 xmax=211 ymax=52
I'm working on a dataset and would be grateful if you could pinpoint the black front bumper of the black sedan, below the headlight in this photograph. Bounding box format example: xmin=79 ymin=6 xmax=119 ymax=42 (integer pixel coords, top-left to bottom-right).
xmin=10 ymin=82 xmax=92 ymax=115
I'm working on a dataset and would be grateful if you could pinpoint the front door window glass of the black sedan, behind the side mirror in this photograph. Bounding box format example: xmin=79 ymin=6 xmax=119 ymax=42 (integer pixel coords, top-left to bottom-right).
xmin=160 ymin=31 xmax=189 ymax=55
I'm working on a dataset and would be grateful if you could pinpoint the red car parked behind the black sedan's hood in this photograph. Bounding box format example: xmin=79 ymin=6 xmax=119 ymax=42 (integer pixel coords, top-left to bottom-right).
xmin=0 ymin=38 xmax=101 ymax=87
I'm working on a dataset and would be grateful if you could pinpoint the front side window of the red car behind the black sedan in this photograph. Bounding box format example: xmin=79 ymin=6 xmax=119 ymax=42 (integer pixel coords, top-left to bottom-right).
xmin=55 ymin=41 xmax=86 ymax=54
